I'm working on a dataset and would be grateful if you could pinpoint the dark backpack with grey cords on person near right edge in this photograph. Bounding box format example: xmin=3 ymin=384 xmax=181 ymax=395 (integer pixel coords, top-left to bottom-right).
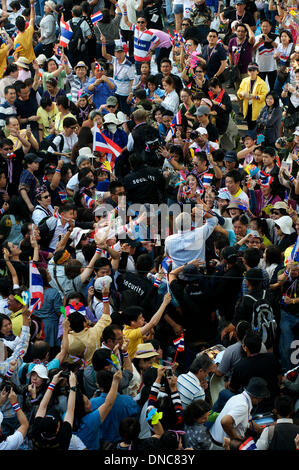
xmin=244 ymin=290 xmax=277 ymax=349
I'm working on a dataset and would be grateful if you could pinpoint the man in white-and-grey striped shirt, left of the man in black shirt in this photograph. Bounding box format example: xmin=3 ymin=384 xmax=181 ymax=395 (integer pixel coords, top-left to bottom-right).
xmin=177 ymin=354 xmax=216 ymax=409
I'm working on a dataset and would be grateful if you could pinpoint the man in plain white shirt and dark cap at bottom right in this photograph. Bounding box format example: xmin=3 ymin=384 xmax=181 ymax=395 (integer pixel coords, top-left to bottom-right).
xmin=210 ymin=377 xmax=270 ymax=445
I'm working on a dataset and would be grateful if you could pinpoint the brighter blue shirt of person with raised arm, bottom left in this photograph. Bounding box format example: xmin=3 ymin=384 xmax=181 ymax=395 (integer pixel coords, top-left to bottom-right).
xmin=74 ymin=398 xmax=103 ymax=450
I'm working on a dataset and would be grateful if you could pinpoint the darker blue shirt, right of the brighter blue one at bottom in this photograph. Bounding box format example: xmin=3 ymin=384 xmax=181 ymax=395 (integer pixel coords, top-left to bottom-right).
xmin=91 ymin=393 xmax=139 ymax=442
